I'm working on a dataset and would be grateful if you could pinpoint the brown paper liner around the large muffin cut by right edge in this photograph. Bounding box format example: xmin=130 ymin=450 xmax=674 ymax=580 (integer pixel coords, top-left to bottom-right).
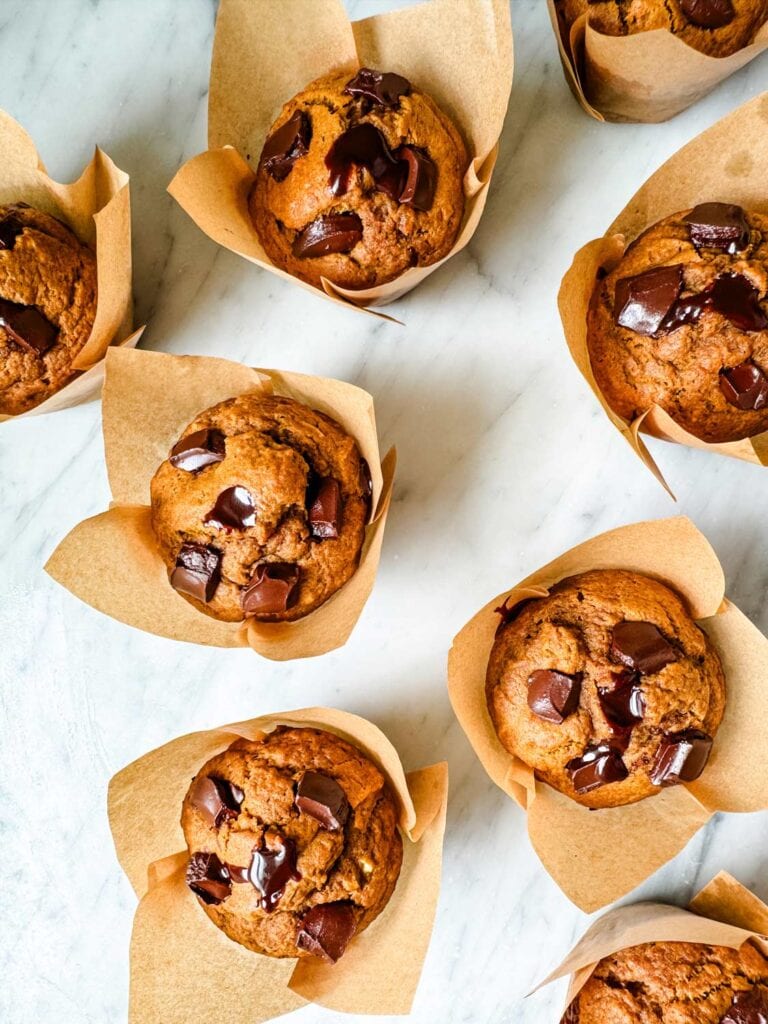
xmin=558 ymin=92 xmax=768 ymax=494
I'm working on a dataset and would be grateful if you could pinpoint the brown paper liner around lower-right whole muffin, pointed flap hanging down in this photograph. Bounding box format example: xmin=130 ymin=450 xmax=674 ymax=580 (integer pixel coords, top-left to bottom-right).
xmin=449 ymin=517 xmax=768 ymax=912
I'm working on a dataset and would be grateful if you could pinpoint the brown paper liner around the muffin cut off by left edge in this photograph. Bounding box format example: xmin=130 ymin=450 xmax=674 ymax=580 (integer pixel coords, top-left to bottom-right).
xmin=0 ymin=111 xmax=141 ymax=421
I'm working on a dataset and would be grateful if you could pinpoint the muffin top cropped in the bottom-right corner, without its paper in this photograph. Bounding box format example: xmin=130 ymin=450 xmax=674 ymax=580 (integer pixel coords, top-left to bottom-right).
xmin=562 ymin=942 xmax=768 ymax=1024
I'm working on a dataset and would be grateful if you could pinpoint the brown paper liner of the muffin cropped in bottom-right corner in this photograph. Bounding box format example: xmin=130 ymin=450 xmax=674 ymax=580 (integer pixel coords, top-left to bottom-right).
xmin=538 ymin=871 xmax=768 ymax=1012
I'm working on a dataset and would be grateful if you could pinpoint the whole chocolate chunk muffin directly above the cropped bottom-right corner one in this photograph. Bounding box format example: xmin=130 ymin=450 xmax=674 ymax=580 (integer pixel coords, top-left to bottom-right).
xmin=485 ymin=569 xmax=725 ymax=808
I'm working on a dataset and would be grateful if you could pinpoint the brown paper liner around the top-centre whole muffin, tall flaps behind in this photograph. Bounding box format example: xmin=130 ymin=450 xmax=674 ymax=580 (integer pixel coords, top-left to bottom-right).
xmin=168 ymin=0 xmax=513 ymax=315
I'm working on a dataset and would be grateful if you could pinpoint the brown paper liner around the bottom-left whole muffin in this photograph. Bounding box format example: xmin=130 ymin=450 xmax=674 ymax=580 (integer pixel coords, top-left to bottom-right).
xmin=109 ymin=708 xmax=447 ymax=1024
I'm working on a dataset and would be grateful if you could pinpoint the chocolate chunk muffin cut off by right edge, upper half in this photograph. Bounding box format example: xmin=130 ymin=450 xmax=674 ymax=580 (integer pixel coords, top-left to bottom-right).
xmin=587 ymin=203 xmax=768 ymax=443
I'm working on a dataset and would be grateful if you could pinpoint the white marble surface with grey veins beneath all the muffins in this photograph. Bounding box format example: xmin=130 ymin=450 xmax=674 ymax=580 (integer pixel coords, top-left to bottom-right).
xmin=0 ymin=0 xmax=768 ymax=1024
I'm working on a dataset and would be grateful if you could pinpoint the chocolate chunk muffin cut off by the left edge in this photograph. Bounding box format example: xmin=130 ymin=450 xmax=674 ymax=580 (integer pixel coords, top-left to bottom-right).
xmin=0 ymin=203 xmax=96 ymax=416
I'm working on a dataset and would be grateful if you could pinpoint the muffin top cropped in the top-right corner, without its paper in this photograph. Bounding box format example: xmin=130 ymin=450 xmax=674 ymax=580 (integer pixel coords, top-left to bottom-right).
xmin=555 ymin=0 xmax=768 ymax=57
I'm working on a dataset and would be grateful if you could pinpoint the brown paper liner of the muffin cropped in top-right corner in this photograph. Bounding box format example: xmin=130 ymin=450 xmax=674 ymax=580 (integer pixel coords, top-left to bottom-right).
xmin=547 ymin=0 xmax=768 ymax=123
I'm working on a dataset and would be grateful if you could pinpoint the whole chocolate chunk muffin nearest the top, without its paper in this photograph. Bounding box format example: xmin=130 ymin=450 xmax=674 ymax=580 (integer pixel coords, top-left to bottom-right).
xmin=249 ymin=68 xmax=468 ymax=289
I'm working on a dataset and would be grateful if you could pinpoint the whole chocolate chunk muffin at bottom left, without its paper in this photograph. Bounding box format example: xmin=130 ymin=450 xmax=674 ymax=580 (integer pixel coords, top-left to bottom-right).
xmin=181 ymin=727 xmax=402 ymax=963
